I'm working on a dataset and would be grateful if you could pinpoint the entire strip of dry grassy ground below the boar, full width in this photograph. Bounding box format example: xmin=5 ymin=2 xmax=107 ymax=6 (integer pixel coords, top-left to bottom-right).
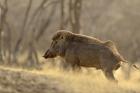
xmin=0 ymin=66 xmax=140 ymax=93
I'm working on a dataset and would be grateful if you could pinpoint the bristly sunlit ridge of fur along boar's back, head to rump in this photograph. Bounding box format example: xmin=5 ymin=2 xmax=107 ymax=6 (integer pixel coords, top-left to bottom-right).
xmin=52 ymin=30 xmax=125 ymax=62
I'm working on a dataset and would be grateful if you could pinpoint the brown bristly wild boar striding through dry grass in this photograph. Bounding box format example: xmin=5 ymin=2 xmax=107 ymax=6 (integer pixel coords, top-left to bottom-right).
xmin=44 ymin=30 xmax=139 ymax=81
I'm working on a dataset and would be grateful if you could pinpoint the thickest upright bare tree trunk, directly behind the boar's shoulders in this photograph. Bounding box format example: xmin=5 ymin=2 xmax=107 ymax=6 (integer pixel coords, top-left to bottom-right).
xmin=69 ymin=0 xmax=82 ymax=33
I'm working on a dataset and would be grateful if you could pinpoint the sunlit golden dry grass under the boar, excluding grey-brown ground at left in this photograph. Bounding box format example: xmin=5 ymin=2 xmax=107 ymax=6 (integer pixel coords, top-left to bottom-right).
xmin=40 ymin=63 xmax=140 ymax=93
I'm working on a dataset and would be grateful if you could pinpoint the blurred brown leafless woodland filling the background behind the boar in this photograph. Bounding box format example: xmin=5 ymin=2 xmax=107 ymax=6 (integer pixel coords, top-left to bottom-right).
xmin=0 ymin=0 xmax=140 ymax=67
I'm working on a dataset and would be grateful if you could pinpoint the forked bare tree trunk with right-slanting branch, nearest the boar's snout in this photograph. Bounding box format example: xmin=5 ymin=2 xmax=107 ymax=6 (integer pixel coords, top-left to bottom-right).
xmin=26 ymin=0 xmax=56 ymax=68
